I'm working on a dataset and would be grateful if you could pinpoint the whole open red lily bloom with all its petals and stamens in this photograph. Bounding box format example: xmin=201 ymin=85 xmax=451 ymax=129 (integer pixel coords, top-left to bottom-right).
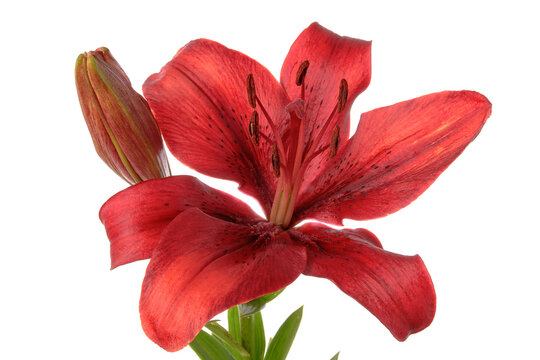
xmin=100 ymin=23 xmax=491 ymax=351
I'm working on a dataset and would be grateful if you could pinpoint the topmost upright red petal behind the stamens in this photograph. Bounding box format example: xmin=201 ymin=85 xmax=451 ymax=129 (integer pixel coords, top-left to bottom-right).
xmin=281 ymin=23 xmax=371 ymax=157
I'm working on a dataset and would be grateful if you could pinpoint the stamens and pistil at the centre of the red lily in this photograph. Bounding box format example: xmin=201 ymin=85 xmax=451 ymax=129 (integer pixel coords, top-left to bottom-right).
xmin=247 ymin=64 xmax=348 ymax=228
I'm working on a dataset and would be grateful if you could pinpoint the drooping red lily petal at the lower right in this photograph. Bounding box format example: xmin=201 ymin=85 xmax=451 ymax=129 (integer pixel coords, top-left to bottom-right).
xmin=293 ymin=223 xmax=436 ymax=341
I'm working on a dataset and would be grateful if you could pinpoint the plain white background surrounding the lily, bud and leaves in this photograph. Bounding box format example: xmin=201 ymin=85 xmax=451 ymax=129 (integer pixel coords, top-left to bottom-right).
xmin=0 ymin=0 xmax=540 ymax=360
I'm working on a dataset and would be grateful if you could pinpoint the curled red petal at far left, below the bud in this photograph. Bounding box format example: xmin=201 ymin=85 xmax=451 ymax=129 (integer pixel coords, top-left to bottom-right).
xmin=99 ymin=176 xmax=258 ymax=269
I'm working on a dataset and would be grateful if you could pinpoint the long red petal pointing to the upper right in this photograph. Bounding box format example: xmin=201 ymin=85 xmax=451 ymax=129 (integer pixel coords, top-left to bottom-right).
xmin=293 ymin=91 xmax=491 ymax=224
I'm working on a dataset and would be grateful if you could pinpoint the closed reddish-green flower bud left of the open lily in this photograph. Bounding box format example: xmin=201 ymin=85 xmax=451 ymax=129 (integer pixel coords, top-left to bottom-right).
xmin=75 ymin=47 xmax=170 ymax=184
